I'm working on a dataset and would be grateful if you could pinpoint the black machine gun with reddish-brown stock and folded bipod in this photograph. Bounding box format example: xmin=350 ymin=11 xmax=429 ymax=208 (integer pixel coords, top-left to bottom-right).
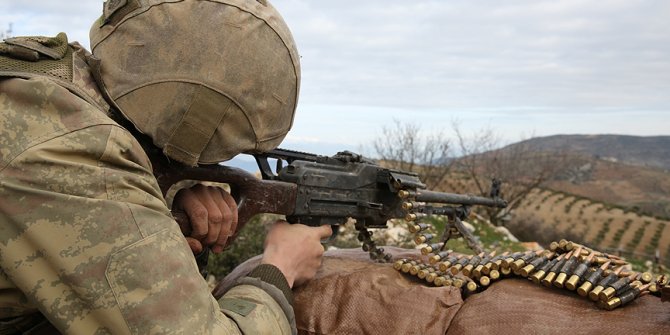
xmin=152 ymin=149 xmax=507 ymax=261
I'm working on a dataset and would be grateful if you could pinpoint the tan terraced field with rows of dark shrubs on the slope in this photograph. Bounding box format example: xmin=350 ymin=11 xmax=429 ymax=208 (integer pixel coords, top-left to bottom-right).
xmin=508 ymin=189 xmax=670 ymax=266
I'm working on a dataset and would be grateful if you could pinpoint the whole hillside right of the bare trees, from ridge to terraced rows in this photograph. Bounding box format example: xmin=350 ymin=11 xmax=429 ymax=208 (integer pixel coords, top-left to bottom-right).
xmin=502 ymin=135 xmax=670 ymax=265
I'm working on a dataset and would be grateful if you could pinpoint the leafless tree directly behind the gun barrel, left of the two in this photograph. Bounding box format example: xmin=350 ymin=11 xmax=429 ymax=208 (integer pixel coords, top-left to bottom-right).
xmin=373 ymin=119 xmax=451 ymax=189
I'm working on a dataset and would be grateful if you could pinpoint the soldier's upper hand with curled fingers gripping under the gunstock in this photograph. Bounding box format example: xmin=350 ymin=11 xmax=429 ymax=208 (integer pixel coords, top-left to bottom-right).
xmin=173 ymin=184 xmax=237 ymax=254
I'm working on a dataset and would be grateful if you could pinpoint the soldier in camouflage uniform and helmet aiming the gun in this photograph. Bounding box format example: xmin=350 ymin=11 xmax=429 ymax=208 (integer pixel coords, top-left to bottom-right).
xmin=0 ymin=0 xmax=331 ymax=334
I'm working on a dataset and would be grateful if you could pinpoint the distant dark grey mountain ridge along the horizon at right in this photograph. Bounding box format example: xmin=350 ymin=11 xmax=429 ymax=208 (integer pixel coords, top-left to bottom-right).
xmin=507 ymin=135 xmax=670 ymax=171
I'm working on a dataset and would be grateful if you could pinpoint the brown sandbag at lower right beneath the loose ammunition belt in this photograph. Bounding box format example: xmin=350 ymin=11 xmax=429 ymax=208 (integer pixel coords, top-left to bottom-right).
xmin=447 ymin=278 xmax=670 ymax=335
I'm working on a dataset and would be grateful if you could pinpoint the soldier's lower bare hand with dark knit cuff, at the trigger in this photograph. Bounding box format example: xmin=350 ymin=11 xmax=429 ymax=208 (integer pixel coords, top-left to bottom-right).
xmin=261 ymin=221 xmax=333 ymax=287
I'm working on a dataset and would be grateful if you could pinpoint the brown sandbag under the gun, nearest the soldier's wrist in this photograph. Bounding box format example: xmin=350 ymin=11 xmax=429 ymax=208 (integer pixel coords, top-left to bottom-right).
xmin=214 ymin=247 xmax=462 ymax=334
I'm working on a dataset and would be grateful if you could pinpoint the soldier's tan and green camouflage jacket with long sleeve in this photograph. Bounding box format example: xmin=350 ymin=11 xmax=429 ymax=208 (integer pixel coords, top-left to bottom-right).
xmin=0 ymin=37 xmax=295 ymax=334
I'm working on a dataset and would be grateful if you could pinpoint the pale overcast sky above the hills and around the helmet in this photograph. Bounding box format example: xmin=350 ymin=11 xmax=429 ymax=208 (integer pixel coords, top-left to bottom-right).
xmin=0 ymin=0 xmax=670 ymax=154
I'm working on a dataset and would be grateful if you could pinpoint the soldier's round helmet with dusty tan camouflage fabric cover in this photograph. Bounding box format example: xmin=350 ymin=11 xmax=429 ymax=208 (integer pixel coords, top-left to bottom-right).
xmin=90 ymin=0 xmax=300 ymax=165
